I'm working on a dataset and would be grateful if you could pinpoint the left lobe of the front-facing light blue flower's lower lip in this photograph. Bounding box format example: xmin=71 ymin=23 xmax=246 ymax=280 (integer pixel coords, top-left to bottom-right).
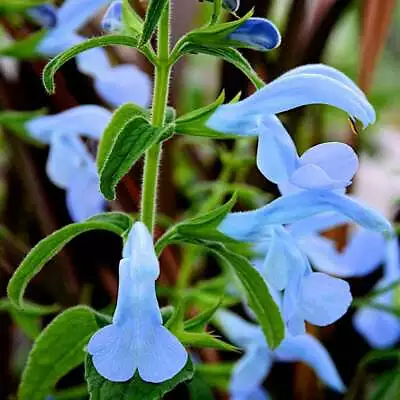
xmin=87 ymin=324 xmax=138 ymax=382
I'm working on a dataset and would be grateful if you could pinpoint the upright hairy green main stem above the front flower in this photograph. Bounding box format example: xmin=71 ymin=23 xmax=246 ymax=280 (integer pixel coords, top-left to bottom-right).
xmin=141 ymin=4 xmax=171 ymax=234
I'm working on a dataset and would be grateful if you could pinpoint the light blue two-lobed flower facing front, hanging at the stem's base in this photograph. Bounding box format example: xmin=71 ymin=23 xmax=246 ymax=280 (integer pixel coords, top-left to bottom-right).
xmin=87 ymin=222 xmax=188 ymax=383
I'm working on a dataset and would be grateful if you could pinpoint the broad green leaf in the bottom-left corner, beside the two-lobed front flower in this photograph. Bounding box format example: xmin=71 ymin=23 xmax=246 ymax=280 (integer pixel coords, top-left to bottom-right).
xmin=18 ymin=306 xmax=98 ymax=400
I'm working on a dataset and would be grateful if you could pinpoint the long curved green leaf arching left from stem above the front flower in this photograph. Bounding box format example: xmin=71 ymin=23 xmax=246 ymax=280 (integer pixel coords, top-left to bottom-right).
xmin=7 ymin=213 xmax=132 ymax=315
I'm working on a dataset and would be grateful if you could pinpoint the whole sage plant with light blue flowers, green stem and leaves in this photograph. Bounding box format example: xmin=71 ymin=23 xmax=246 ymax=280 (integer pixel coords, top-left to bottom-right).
xmin=1 ymin=0 xmax=400 ymax=400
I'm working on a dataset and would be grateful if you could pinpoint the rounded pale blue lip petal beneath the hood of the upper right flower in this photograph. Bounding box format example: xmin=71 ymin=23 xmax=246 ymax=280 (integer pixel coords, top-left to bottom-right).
xmin=300 ymin=142 xmax=359 ymax=182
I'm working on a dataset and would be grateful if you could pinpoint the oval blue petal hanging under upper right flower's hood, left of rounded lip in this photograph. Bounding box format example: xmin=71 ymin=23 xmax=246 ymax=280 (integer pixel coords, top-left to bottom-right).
xmin=257 ymin=116 xmax=299 ymax=183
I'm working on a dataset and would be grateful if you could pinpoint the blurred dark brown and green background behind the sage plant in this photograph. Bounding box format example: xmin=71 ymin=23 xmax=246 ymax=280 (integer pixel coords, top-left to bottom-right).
xmin=0 ymin=0 xmax=400 ymax=400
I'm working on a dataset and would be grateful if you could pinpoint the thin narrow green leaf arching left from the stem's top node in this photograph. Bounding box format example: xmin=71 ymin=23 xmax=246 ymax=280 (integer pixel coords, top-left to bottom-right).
xmin=43 ymin=35 xmax=137 ymax=94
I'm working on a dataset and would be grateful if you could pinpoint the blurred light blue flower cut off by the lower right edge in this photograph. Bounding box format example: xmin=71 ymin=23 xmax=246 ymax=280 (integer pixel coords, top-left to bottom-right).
xmin=353 ymin=238 xmax=400 ymax=348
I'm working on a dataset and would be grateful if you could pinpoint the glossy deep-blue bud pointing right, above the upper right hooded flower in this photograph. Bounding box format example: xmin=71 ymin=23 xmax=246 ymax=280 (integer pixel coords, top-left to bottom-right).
xmin=229 ymin=18 xmax=281 ymax=51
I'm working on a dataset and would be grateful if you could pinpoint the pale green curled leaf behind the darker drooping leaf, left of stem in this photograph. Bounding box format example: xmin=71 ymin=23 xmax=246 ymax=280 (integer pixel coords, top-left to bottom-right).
xmin=97 ymin=103 xmax=147 ymax=171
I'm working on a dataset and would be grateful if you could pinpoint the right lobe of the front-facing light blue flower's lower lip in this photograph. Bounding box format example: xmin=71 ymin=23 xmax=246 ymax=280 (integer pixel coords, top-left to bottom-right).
xmin=137 ymin=321 xmax=188 ymax=383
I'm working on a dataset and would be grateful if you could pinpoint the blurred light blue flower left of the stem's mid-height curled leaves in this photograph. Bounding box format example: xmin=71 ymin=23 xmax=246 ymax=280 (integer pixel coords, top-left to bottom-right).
xmin=26 ymin=105 xmax=111 ymax=221
